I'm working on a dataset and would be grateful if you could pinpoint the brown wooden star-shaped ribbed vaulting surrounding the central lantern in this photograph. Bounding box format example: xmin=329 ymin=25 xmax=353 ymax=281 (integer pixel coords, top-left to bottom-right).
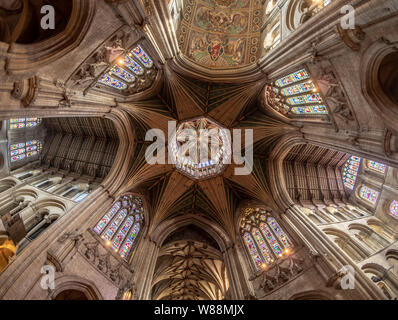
xmin=116 ymin=66 xmax=296 ymax=235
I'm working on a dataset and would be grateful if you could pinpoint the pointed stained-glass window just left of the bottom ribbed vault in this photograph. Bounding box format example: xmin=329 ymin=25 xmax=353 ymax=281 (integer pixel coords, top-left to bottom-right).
xmin=94 ymin=195 xmax=145 ymax=260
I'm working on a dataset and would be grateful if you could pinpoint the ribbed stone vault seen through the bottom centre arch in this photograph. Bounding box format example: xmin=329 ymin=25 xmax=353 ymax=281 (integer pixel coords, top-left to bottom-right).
xmin=152 ymin=240 xmax=229 ymax=300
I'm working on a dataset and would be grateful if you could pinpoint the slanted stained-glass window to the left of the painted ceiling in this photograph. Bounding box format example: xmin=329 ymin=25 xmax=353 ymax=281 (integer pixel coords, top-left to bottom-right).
xmin=98 ymin=45 xmax=153 ymax=91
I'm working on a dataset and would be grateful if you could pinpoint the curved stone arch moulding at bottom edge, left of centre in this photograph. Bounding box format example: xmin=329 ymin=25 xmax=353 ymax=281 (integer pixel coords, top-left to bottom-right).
xmin=47 ymin=275 xmax=103 ymax=300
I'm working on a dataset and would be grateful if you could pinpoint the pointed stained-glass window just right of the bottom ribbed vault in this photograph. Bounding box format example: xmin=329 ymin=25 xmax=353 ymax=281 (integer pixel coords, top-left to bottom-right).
xmin=240 ymin=208 xmax=293 ymax=270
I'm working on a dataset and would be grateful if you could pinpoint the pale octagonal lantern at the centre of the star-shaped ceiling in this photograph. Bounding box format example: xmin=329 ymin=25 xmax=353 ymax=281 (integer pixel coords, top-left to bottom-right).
xmin=170 ymin=117 xmax=231 ymax=179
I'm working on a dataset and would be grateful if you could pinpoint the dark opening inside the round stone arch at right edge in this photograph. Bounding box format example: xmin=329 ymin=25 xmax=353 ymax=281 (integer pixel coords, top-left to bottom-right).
xmin=378 ymin=52 xmax=398 ymax=105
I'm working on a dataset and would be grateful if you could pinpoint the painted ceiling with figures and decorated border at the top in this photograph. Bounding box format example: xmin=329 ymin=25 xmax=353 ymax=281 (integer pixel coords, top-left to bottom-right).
xmin=177 ymin=0 xmax=263 ymax=68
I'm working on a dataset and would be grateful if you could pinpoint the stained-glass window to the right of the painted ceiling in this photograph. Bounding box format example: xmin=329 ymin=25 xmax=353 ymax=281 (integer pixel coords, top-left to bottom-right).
xmin=274 ymin=69 xmax=328 ymax=115
